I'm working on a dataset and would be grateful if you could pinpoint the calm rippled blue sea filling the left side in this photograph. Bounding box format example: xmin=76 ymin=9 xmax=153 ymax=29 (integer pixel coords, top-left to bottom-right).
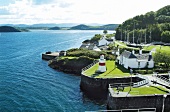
xmin=0 ymin=30 xmax=114 ymax=112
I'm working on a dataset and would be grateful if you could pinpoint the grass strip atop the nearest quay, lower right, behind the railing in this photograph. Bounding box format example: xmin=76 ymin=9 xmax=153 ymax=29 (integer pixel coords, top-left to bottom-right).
xmin=113 ymin=86 xmax=170 ymax=95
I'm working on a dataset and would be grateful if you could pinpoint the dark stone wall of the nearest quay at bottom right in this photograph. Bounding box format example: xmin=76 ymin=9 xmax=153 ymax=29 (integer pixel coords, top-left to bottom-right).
xmin=107 ymin=94 xmax=170 ymax=112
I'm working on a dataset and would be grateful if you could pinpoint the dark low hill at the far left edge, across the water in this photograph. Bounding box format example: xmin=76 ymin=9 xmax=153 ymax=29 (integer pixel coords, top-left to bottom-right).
xmin=0 ymin=26 xmax=21 ymax=32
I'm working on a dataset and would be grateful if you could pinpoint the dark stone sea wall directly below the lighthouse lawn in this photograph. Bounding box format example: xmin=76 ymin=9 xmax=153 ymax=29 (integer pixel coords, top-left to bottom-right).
xmin=80 ymin=74 xmax=141 ymax=100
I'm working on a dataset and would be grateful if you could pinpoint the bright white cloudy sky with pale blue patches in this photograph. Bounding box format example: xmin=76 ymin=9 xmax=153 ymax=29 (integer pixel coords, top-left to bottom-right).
xmin=0 ymin=0 xmax=170 ymax=24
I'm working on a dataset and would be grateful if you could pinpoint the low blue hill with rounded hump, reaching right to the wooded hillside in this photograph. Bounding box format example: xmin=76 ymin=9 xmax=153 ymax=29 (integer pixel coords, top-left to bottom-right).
xmin=70 ymin=24 xmax=118 ymax=30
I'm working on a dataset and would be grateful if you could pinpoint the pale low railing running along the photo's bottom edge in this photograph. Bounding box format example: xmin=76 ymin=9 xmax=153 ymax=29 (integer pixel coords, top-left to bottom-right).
xmin=88 ymin=108 xmax=156 ymax=112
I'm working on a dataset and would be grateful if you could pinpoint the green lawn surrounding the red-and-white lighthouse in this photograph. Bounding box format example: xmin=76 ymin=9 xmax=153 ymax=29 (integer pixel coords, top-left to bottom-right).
xmin=84 ymin=61 xmax=130 ymax=78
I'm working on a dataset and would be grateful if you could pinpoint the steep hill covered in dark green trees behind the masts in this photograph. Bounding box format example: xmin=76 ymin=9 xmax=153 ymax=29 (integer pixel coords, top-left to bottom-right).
xmin=115 ymin=5 xmax=170 ymax=43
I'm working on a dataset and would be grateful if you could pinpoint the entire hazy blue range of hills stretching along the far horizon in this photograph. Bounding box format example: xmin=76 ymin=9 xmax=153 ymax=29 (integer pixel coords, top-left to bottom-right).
xmin=1 ymin=23 xmax=118 ymax=30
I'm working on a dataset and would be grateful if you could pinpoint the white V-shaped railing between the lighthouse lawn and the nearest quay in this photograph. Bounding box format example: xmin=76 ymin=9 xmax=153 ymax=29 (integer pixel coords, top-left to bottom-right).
xmin=133 ymin=74 xmax=149 ymax=87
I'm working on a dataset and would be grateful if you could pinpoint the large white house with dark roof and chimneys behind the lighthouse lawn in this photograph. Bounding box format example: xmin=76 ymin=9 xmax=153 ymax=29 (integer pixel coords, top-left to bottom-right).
xmin=117 ymin=50 xmax=154 ymax=69
